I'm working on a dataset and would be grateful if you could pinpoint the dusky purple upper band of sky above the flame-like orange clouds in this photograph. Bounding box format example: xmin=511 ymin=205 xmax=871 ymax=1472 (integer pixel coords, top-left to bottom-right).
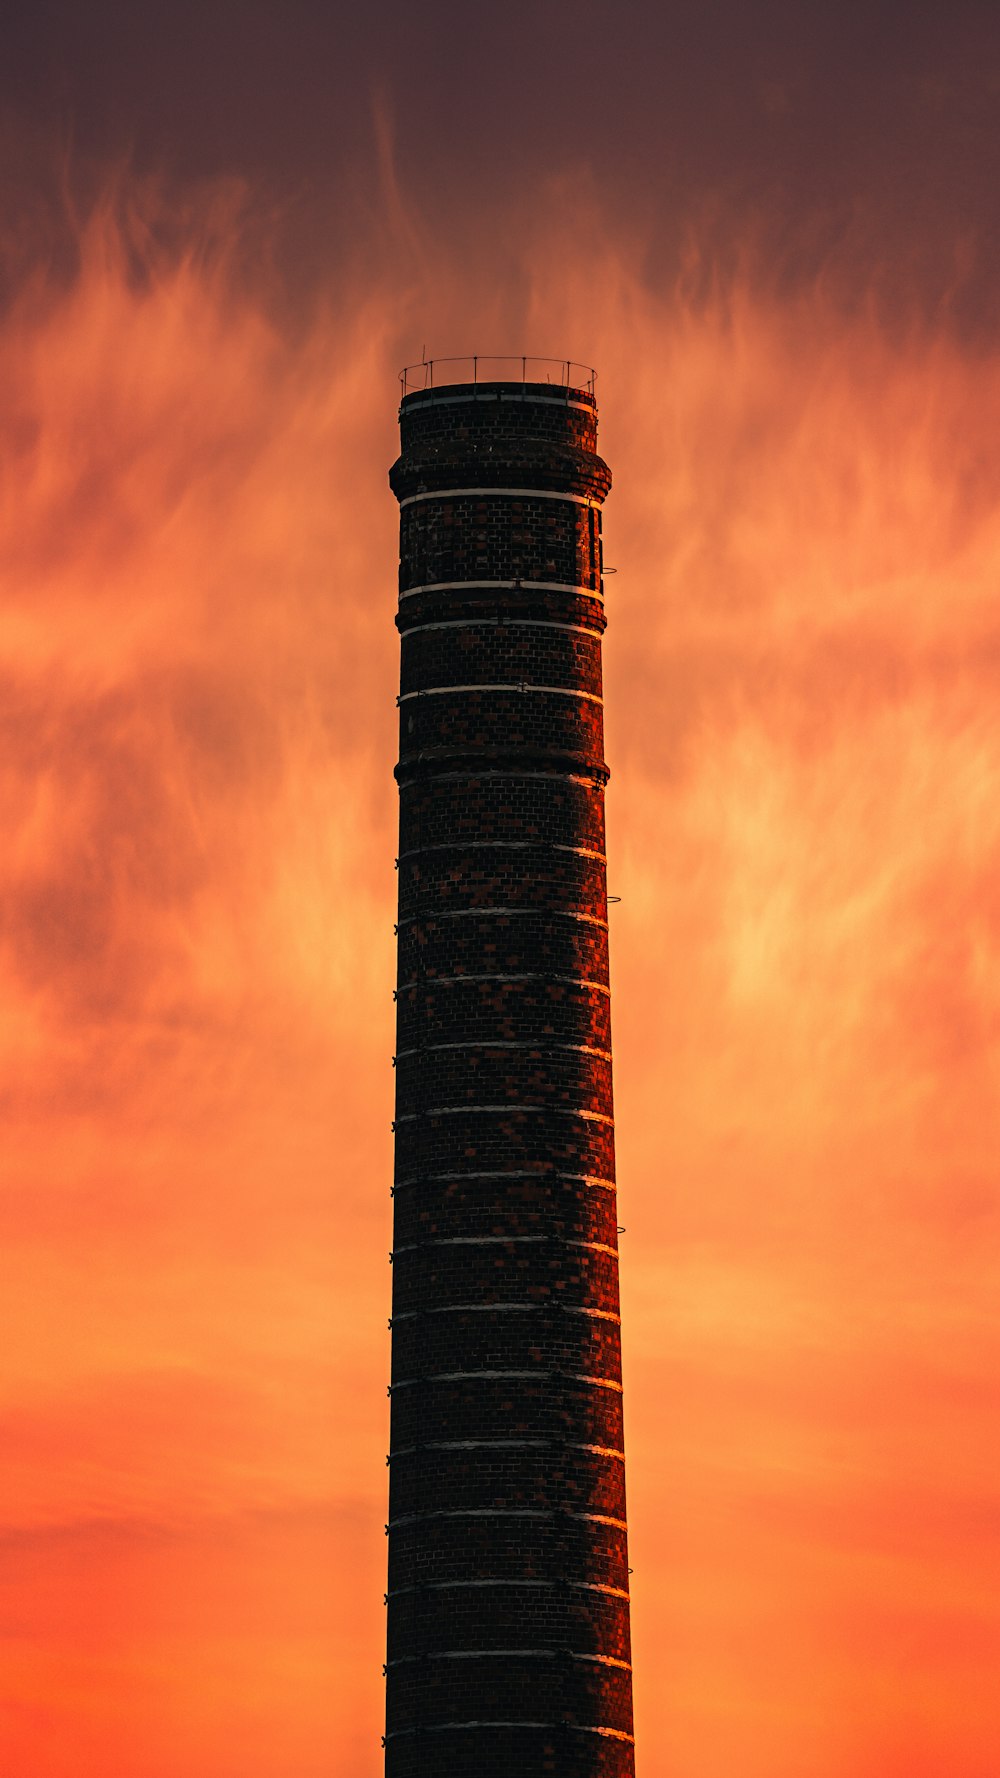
xmin=0 ymin=0 xmax=1000 ymax=334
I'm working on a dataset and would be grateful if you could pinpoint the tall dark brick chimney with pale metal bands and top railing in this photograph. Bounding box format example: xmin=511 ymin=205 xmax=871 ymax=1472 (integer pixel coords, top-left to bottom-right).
xmin=386 ymin=359 xmax=633 ymax=1778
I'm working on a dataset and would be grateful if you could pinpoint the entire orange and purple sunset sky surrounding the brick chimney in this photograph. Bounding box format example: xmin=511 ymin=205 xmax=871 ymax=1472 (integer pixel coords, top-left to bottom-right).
xmin=0 ymin=0 xmax=1000 ymax=1778
